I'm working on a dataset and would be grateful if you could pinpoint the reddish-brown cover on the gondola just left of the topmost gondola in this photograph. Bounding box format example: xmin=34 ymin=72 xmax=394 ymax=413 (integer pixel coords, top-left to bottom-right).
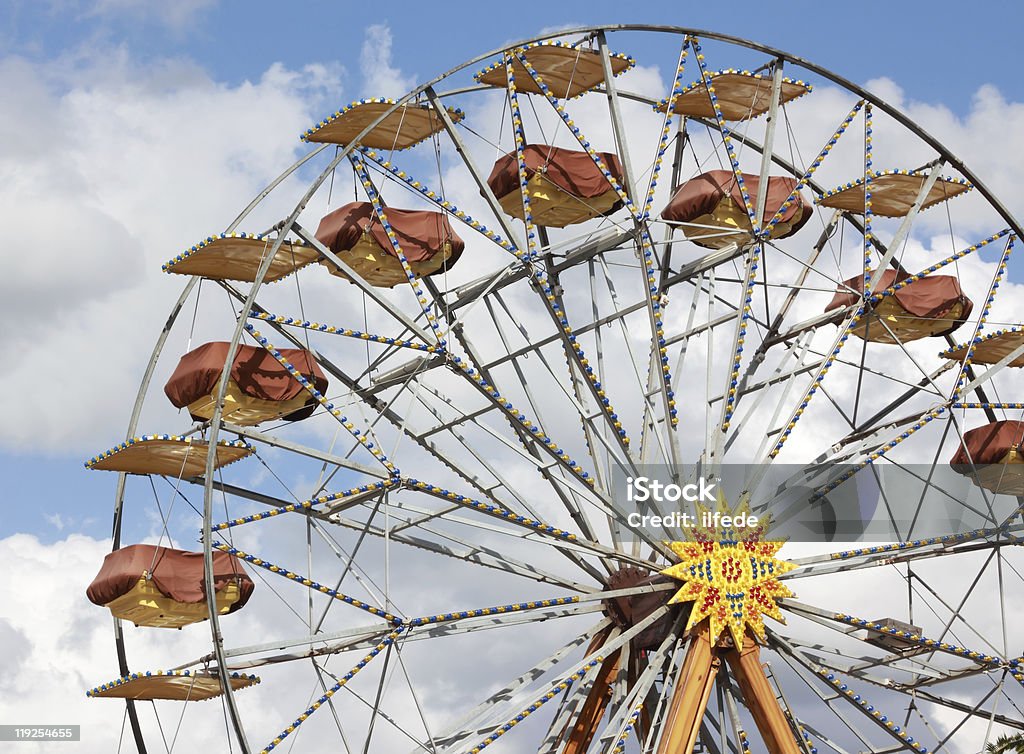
xmin=316 ymin=202 xmax=466 ymax=266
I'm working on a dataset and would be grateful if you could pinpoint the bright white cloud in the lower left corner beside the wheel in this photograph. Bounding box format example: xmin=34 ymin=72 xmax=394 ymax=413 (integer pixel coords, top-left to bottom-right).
xmin=0 ymin=534 xmax=294 ymax=754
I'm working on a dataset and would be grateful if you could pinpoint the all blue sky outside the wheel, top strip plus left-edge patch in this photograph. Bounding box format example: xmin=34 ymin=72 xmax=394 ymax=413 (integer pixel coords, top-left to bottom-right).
xmin=0 ymin=0 xmax=1024 ymax=541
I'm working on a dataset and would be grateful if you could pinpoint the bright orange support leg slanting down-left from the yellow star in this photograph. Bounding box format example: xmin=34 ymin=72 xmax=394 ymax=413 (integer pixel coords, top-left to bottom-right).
xmin=657 ymin=621 xmax=722 ymax=754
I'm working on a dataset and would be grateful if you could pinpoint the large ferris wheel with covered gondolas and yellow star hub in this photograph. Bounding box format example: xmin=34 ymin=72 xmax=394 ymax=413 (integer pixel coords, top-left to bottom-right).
xmin=86 ymin=26 xmax=1024 ymax=754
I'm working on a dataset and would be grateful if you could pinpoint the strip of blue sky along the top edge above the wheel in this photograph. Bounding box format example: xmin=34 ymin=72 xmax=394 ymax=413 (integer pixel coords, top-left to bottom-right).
xmin=8 ymin=0 xmax=1024 ymax=112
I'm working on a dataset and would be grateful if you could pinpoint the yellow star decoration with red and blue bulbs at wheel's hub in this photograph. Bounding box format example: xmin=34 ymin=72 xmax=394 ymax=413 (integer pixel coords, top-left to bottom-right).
xmin=662 ymin=499 xmax=797 ymax=648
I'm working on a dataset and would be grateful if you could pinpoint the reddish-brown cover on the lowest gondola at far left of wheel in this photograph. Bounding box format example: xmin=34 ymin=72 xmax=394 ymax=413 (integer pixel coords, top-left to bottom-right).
xmin=86 ymin=545 xmax=253 ymax=613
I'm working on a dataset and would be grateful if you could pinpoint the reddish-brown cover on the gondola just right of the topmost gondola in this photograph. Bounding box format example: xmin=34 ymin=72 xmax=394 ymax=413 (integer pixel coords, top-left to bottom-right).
xmin=662 ymin=170 xmax=814 ymax=234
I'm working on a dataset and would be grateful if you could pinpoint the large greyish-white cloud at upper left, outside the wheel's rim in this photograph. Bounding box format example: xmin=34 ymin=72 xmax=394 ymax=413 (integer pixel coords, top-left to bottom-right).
xmin=0 ymin=49 xmax=340 ymax=452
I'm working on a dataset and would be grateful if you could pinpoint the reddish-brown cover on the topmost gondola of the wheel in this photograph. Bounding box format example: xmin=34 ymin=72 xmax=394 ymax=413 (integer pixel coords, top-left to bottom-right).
xmin=487 ymin=144 xmax=623 ymax=205
